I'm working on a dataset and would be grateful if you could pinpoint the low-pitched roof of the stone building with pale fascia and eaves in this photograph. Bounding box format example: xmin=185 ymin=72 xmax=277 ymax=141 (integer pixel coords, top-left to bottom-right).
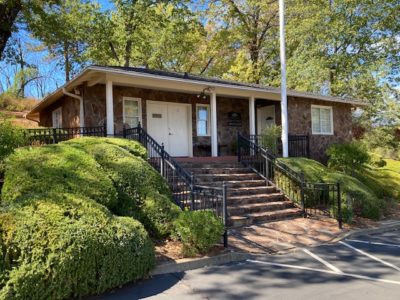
xmin=27 ymin=65 xmax=367 ymax=119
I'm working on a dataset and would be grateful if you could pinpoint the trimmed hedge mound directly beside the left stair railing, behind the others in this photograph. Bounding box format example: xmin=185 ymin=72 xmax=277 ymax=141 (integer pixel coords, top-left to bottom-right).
xmin=64 ymin=138 xmax=180 ymax=238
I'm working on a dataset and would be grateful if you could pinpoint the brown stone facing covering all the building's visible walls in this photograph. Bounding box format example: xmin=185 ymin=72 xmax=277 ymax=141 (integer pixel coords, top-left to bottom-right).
xmin=39 ymin=85 xmax=352 ymax=161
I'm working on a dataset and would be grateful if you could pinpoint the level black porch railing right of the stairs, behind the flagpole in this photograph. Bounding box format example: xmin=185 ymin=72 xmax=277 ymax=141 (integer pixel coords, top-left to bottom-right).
xmin=249 ymin=134 xmax=310 ymax=157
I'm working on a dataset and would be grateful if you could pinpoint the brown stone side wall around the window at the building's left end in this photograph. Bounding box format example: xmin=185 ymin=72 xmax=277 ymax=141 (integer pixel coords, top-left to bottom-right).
xmin=39 ymin=96 xmax=80 ymax=128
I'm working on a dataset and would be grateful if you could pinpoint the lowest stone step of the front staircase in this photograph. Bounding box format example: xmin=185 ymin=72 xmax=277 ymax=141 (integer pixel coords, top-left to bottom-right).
xmin=228 ymin=201 xmax=294 ymax=216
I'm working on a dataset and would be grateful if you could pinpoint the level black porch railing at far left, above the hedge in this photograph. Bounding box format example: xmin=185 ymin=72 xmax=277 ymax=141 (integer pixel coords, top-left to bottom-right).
xmin=24 ymin=125 xmax=107 ymax=144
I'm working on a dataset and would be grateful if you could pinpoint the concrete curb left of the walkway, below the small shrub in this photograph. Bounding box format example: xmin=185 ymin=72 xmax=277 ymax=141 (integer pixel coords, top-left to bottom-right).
xmin=150 ymin=252 xmax=252 ymax=276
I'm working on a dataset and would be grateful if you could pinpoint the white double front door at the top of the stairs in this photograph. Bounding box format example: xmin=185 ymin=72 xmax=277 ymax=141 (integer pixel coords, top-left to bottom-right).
xmin=147 ymin=101 xmax=191 ymax=156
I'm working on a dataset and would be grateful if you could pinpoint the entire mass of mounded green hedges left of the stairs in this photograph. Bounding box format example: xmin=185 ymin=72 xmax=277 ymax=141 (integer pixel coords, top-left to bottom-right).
xmin=0 ymin=138 xmax=179 ymax=299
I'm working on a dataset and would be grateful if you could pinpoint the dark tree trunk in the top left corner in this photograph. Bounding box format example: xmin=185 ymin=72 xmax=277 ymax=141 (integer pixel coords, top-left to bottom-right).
xmin=0 ymin=0 xmax=22 ymax=60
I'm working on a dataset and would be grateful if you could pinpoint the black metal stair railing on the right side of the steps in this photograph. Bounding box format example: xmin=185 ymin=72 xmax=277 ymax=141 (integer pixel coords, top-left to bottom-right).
xmin=238 ymin=134 xmax=342 ymax=228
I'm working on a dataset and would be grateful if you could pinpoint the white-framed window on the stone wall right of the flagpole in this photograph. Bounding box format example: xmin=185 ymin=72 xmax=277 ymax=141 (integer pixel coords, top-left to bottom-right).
xmin=311 ymin=105 xmax=333 ymax=135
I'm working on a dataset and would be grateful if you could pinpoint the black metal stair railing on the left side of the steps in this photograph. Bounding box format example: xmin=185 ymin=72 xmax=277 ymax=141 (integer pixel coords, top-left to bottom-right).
xmin=123 ymin=124 xmax=228 ymax=246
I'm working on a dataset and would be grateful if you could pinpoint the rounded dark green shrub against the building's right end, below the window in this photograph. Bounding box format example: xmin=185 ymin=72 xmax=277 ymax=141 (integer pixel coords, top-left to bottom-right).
xmin=326 ymin=142 xmax=370 ymax=174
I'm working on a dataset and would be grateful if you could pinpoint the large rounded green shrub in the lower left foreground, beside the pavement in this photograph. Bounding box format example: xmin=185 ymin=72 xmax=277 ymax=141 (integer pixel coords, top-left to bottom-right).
xmin=0 ymin=195 xmax=155 ymax=299
